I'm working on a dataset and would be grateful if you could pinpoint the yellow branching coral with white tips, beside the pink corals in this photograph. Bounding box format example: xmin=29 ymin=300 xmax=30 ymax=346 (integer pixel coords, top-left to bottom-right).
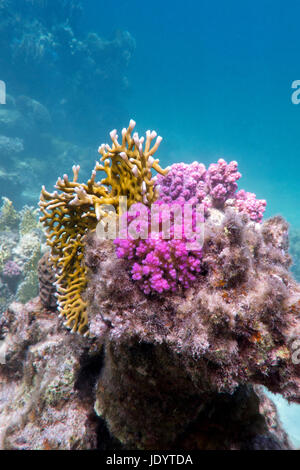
xmin=39 ymin=120 xmax=168 ymax=334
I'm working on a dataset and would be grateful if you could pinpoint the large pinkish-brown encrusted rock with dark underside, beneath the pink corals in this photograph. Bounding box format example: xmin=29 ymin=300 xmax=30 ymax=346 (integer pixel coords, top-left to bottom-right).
xmin=86 ymin=208 xmax=300 ymax=448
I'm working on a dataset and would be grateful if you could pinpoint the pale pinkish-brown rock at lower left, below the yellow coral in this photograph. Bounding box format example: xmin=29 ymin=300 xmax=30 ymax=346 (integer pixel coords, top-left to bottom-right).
xmin=0 ymin=298 xmax=101 ymax=450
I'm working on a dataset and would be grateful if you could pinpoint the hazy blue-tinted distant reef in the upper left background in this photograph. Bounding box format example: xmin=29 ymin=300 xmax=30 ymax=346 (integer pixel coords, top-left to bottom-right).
xmin=0 ymin=0 xmax=135 ymax=207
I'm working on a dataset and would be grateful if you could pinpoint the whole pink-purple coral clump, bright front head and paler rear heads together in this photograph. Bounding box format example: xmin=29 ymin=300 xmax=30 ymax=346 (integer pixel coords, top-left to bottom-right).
xmin=114 ymin=159 xmax=266 ymax=294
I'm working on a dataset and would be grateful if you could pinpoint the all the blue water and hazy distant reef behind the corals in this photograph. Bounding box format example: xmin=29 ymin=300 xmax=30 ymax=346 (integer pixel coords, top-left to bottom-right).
xmin=0 ymin=0 xmax=300 ymax=446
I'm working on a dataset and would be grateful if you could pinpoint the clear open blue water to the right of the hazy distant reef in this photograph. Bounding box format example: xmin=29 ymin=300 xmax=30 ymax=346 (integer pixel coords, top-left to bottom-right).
xmin=81 ymin=0 xmax=300 ymax=226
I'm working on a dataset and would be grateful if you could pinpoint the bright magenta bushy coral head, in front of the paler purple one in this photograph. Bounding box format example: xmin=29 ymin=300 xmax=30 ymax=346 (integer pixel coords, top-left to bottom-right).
xmin=114 ymin=202 xmax=202 ymax=294
